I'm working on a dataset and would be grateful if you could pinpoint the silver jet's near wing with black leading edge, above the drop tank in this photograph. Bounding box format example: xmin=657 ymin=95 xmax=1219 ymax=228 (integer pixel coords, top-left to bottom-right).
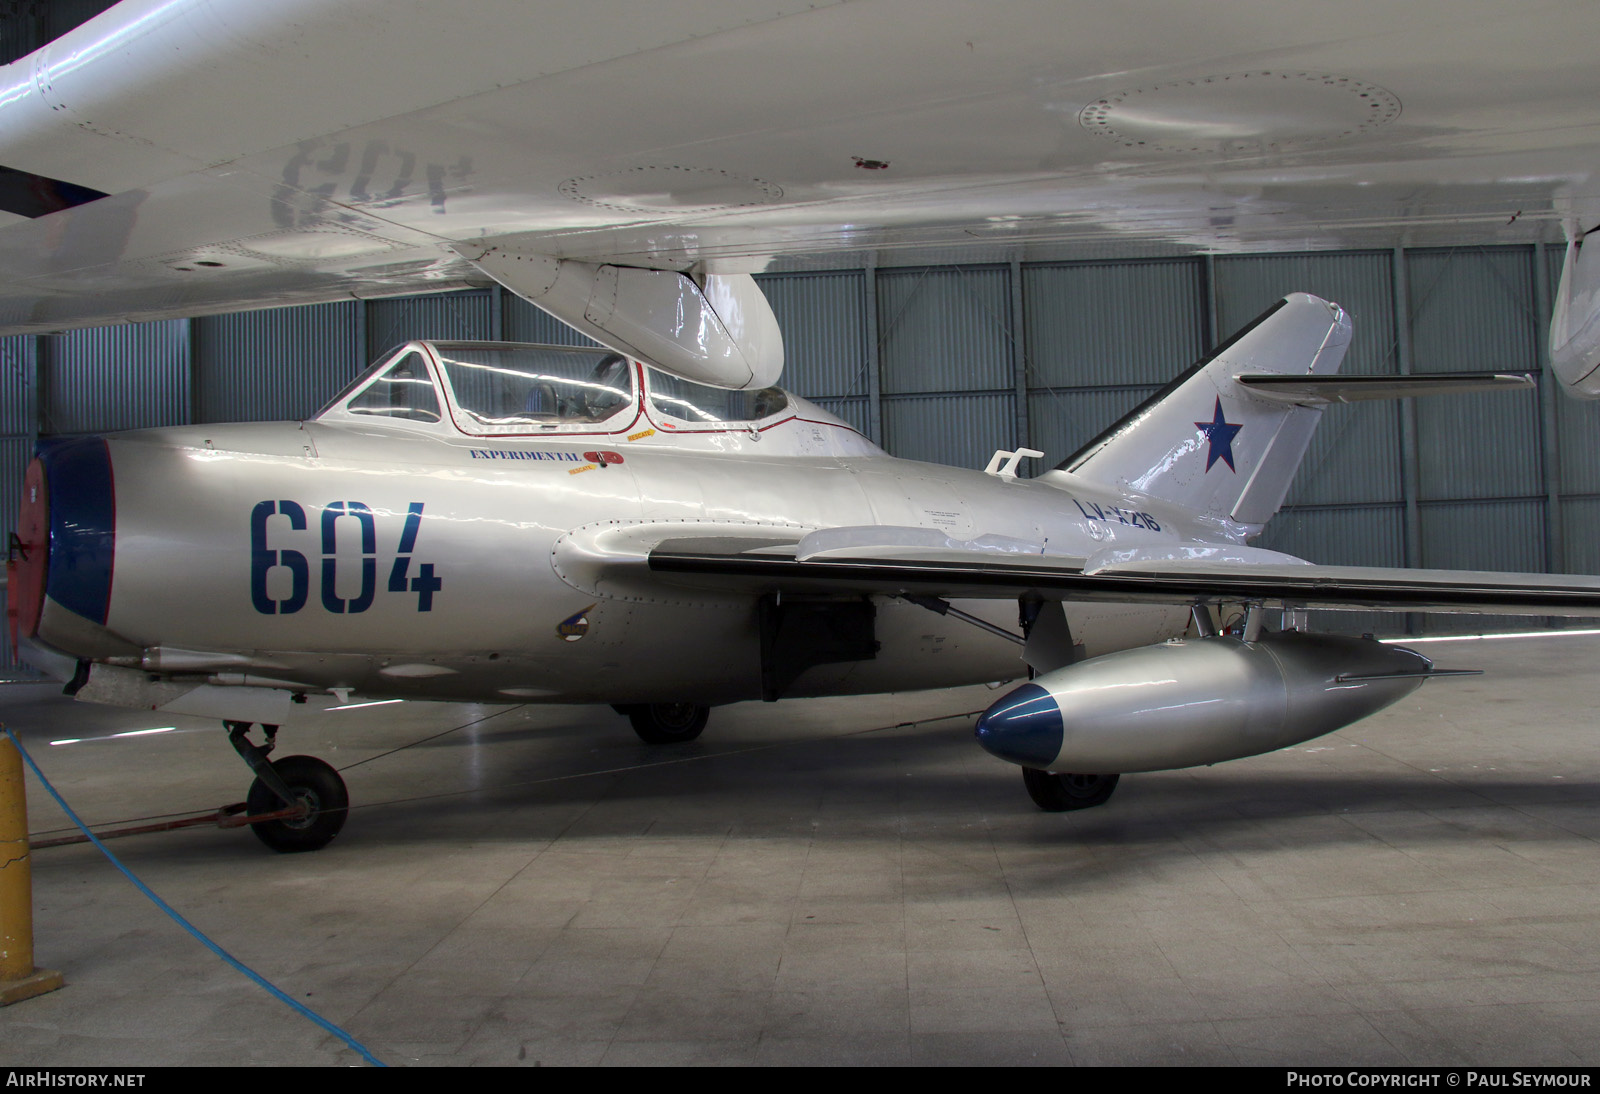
xmin=555 ymin=521 xmax=1600 ymax=617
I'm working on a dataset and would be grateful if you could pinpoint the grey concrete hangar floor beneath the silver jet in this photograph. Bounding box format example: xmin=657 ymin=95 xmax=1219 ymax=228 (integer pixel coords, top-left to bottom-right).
xmin=0 ymin=637 xmax=1600 ymax=1067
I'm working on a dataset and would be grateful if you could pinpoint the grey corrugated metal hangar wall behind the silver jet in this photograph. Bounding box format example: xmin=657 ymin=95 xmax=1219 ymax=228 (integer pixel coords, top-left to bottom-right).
xmin=0 ymin=246 xmax=1600 ymax=671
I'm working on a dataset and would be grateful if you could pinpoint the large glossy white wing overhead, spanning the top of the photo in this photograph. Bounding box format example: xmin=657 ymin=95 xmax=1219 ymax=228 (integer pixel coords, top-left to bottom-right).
xmin=0 ymin=0 xmax=1600 ymax=383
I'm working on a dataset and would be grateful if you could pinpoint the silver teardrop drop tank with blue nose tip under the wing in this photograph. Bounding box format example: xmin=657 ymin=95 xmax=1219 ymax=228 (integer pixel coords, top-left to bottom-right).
xmin=976 ymin=632 xmax=1432 ymax=774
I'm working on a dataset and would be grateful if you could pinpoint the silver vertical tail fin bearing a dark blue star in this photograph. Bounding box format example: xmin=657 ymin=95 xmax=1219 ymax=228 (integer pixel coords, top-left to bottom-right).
xmin=1059 ymin=293 xmax=1350 ymax=525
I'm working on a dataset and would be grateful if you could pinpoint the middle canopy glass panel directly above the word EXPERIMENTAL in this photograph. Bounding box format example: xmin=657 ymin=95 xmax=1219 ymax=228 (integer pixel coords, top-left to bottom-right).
xmin=434 ymin=342 xmax=634 ymax=437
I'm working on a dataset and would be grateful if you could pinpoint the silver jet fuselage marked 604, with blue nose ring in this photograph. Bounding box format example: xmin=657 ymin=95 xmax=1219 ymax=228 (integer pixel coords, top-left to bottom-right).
xmin=21 ymin=345 xmax=1206 ymax=704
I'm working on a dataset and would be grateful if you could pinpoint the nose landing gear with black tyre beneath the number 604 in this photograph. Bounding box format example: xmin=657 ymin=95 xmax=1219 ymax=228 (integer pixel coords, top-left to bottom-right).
xmin=222 ymin=721 xmax=350 ymax=854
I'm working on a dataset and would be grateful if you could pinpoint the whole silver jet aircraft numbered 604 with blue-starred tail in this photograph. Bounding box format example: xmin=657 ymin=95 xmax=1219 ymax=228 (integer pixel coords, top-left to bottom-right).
xmin=10 ymin=294 xmax=1600 ymax=851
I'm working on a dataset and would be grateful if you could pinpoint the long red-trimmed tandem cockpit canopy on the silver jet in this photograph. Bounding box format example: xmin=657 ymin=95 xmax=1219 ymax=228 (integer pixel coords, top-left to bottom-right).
xmin=317 ymin=342 xmax=790 ymax=437
